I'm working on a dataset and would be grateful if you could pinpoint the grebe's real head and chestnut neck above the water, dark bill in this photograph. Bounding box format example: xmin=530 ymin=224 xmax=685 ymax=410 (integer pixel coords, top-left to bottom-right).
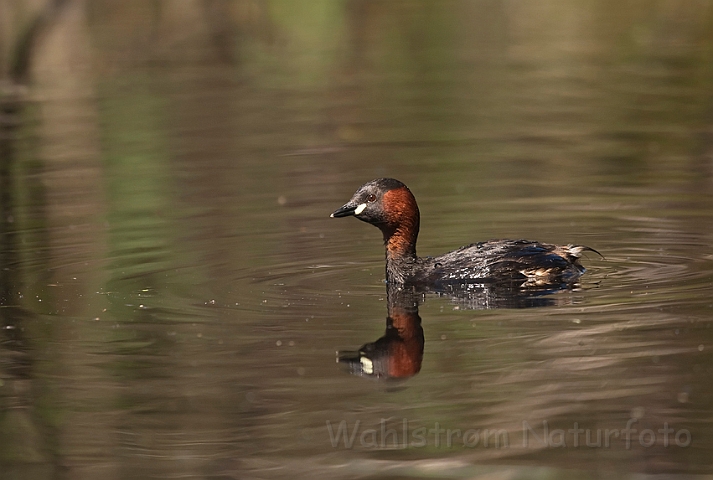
xmin=330 ymin=178 xmax=420 ymax=256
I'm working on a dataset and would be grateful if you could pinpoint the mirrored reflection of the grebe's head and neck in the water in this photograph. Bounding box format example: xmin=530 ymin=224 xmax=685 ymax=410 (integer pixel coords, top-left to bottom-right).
xmin=338 ymin=286 xmax=424 ymax=379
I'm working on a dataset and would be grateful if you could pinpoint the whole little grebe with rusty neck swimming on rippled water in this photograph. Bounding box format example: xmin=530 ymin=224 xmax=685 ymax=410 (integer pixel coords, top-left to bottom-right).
xmin=331 ymin=178 xmax=596 ymax=286
